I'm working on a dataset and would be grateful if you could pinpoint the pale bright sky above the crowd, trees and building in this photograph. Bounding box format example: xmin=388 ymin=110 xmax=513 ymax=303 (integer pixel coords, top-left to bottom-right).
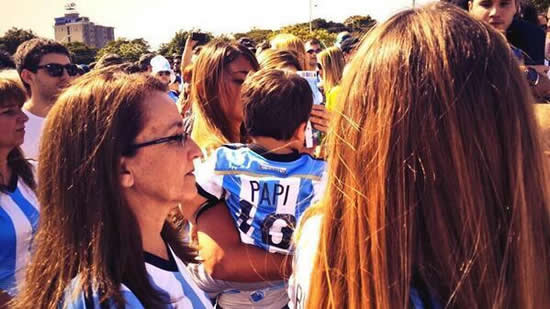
xmin=0 ymin=0 xmax=433 ymax=48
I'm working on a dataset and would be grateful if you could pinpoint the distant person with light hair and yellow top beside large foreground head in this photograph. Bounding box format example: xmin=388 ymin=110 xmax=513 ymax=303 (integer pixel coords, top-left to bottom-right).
xmin=317 ymin=46 xmax=346 ymax=111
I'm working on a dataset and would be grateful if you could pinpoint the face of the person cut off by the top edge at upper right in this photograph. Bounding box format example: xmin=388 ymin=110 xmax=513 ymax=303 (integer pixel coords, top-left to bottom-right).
xmin=468 ymin=0 xmax=517 ymax=33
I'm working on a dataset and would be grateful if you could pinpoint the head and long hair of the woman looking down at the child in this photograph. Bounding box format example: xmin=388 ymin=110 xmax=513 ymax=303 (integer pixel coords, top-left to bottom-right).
xmin=191 ymin=40 xmax=259 ymax=152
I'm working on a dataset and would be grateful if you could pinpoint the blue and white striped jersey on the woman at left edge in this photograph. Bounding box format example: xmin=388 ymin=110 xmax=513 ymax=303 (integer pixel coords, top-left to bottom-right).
xmin=0 ymin=178 xmax=39 ymax=296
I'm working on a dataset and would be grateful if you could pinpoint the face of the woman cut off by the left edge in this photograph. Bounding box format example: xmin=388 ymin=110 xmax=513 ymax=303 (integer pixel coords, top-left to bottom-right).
xmin=0 ymin=102 xmax=29 ymax=150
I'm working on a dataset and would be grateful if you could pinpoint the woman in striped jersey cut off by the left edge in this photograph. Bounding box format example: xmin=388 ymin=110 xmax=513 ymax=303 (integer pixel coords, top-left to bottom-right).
xmin=0 ymin=70 xmax=39 ymax=308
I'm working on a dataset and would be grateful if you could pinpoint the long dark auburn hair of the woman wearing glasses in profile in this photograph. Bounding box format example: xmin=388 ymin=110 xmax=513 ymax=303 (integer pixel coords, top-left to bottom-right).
xmin=13 ymin=66 xmax=195 ymax=308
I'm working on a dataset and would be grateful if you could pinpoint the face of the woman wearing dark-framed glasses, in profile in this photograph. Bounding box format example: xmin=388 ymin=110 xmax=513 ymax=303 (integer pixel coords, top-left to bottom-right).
xmin=126 ymin=91 xmax=201 ymax=206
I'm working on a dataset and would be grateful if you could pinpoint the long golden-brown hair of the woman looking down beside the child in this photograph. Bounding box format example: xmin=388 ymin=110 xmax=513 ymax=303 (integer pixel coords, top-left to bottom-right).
xmin=191 ymin=40 xmax=258 ymax=149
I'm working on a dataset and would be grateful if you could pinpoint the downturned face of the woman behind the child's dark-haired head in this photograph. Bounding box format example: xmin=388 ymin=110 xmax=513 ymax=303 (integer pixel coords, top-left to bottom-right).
xmin=222 ymin=56 xmax=254 ymax=123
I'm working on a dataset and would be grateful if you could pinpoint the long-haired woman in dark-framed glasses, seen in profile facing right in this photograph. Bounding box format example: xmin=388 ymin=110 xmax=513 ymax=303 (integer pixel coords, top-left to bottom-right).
xmin=13 ymin=68 xmax=211 ymax=308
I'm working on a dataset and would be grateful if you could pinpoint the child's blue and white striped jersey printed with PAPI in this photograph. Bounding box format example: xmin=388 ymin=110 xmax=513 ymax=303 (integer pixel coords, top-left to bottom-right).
xmin=195 ymin=144 xmax=326 ymax=254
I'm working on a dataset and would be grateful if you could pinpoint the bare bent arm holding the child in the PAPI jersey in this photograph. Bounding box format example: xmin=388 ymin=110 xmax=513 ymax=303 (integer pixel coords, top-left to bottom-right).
xmin=196 ymin=201 xmax=292 ymax=282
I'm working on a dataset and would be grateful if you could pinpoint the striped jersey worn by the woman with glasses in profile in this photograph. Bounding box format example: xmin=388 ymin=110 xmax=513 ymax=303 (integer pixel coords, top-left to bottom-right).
xmin=60 ymin=250 xmax=212 ymax=309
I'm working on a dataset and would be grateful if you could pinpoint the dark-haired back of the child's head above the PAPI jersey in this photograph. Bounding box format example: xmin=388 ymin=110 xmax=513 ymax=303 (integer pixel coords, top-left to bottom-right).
xmin=241 ymin=69 xmax=313 ymax=143
